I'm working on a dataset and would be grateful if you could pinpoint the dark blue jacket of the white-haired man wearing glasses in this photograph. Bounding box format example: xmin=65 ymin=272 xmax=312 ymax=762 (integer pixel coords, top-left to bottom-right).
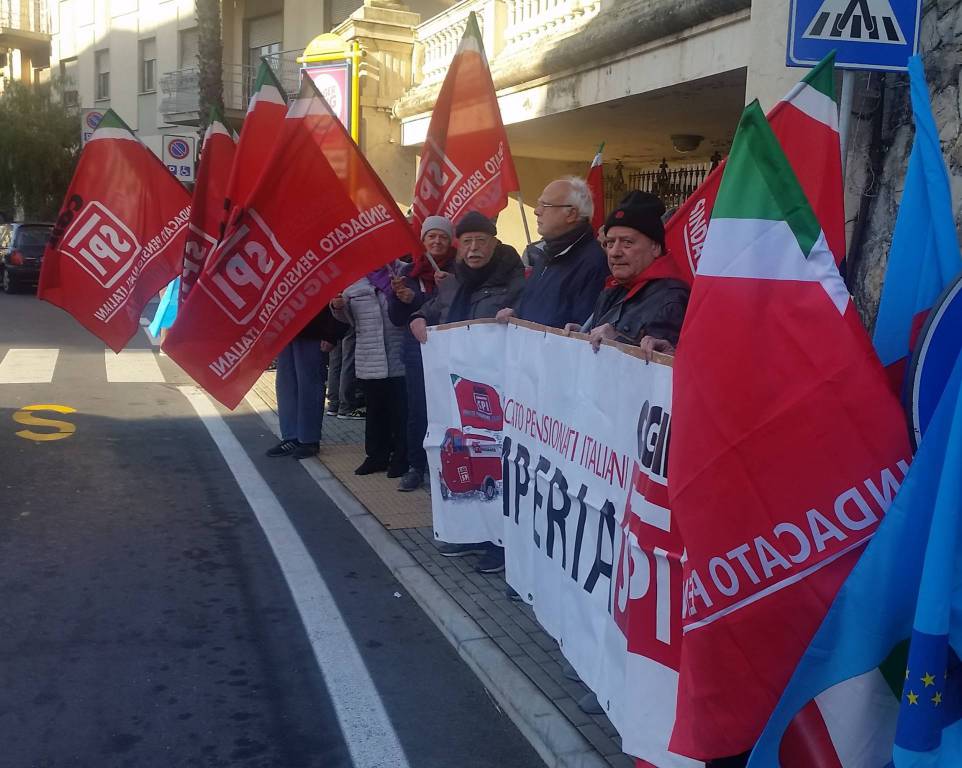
xmin=515 ymin=222 xmax=609 ymax=328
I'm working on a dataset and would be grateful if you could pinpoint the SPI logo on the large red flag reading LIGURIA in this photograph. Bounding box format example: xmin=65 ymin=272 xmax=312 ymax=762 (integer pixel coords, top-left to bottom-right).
xmin=198 ymin=209 xmax=291 ymax=325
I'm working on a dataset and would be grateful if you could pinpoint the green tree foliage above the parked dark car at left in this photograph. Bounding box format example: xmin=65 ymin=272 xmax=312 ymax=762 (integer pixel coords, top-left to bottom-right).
xmin=0 ymin=82 xmax=80 ymax=221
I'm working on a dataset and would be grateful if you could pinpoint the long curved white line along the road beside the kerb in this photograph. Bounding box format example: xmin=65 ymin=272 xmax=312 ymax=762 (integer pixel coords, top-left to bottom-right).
xmin=178 ymin=386 xmax=409 ymax=768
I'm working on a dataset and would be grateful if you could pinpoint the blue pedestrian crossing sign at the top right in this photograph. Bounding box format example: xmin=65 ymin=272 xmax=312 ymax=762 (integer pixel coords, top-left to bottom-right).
xmin=786 ymin=0 xmax=922 ymax=71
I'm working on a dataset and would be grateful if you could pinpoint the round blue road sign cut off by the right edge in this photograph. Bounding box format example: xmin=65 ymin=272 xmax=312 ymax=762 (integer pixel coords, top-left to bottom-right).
xmin=906 ymin=275 xmax=962 ymax=448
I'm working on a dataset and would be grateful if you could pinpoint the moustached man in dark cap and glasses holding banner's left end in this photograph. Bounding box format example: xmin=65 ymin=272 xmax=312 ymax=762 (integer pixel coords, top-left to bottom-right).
xmin=410 ymin=211 xmax=524 ymax=573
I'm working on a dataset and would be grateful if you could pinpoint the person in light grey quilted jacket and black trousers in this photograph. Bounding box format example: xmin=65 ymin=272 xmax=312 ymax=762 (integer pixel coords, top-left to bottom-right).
xmin=331 ymin=268 xmax=408 ymax=477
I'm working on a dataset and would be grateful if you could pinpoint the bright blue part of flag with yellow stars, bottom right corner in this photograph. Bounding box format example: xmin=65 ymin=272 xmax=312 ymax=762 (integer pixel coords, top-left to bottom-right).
xmin=748 ymin=344 xmax=962 ymax=768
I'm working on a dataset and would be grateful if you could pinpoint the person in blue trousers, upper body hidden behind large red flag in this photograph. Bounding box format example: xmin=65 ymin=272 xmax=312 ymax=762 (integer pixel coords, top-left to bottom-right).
xmin=267 ymin=307 xmax=347 ymax=459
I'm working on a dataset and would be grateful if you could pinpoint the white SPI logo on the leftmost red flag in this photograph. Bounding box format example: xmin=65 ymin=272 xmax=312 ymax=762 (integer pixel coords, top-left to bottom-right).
xmin=60 ymin=200 xmax=140 ymax=288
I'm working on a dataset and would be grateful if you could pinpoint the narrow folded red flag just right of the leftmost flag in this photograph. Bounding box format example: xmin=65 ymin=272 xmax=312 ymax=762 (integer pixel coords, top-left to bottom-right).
xmin=179 ymin=109 xmax=235 ymax=304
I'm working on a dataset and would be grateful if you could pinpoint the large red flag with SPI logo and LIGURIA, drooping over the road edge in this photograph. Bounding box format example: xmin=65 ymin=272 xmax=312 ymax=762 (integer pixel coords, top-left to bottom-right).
xmin=164 ymin=78 xmax=420 ymax=408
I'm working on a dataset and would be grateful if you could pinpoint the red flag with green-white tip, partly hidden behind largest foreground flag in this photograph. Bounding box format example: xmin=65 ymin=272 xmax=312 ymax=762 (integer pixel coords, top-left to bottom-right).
xmin=665 ymin=53 xmax=845 ymax=283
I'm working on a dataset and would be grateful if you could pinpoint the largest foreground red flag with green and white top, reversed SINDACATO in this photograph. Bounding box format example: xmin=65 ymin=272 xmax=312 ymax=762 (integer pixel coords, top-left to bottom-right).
xmin=668 ymin=102 xmax=911 ymax=765
